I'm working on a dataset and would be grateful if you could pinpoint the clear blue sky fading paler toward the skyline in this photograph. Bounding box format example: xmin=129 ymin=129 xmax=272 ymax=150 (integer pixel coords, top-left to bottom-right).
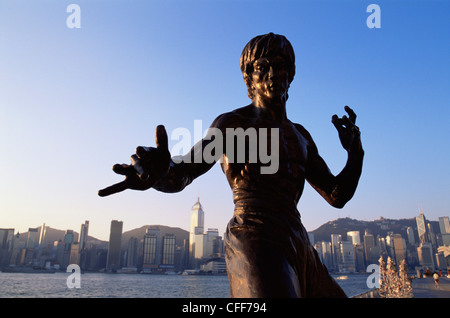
xmin=0 ymin=0 xmax=450 ymax=239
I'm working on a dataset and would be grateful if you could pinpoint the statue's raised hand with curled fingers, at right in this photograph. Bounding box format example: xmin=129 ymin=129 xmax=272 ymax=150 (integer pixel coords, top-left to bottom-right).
xmin=331 ymin=106 xmax=362 ymax=151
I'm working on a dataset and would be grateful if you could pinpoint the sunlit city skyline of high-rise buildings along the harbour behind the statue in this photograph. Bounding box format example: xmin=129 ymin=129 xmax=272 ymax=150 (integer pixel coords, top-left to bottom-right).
xmin=0 ymin=205 xmax=450 ymax=274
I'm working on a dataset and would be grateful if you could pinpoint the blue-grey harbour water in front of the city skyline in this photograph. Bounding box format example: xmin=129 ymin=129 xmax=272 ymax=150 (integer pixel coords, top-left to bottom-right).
xmin=0 ymin=272 xmax=370 ymax=298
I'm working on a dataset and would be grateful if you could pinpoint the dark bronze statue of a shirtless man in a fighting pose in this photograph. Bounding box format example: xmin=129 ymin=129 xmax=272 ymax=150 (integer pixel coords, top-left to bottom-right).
xmin=99 ymin=33 xmax=364 ymax=298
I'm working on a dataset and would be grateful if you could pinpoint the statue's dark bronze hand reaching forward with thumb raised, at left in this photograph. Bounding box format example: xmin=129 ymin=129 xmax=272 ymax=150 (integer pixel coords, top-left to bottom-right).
xmin=98 ymin=125 xmax=170 ymax=197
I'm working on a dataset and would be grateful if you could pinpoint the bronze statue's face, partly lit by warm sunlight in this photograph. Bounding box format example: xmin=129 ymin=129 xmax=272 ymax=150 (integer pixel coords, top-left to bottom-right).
xmin=252 ymin=56 xmax=289 ymax=100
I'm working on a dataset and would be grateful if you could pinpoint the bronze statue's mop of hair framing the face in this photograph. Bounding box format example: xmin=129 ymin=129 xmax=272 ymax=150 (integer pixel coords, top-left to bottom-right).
xmin=240 ymin=32 xmax=295 ymax=100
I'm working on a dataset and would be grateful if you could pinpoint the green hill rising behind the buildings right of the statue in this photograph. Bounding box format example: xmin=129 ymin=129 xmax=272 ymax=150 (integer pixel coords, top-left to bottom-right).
xmin=311 ymin=217 xmax=439 ymax=242
